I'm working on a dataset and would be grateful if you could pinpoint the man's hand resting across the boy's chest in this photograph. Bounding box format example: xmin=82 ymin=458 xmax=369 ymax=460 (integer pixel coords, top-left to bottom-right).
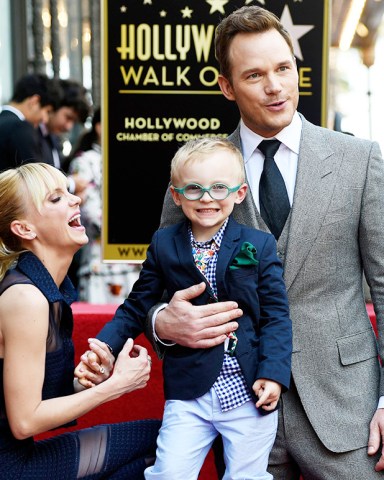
xmin=156 ymin=282 xmax=243 ymax=348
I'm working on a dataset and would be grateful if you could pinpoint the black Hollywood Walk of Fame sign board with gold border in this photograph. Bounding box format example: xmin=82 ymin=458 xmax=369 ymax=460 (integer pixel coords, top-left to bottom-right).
xmin=102 ymin=0 xmax=330 ymax=263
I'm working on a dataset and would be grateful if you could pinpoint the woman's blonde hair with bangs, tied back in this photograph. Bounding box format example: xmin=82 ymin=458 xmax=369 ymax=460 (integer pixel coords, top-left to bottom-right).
xmin=0 ymin=163 xmax=68 ymax=280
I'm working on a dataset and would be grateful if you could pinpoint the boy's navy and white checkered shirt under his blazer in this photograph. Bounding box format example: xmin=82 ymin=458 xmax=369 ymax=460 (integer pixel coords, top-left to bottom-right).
xmin=189 ymin=219 xmax=251 ymax=412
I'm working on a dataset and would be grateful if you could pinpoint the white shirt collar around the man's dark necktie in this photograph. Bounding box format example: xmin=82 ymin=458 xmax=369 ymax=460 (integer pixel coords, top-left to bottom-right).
xmin=240 ymin=112 xmax=302 ymax=163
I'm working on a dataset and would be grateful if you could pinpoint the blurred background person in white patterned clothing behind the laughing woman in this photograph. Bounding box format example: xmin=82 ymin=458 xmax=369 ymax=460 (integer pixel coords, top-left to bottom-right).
xmin=68 ymin=108 xmax=141 ymax=304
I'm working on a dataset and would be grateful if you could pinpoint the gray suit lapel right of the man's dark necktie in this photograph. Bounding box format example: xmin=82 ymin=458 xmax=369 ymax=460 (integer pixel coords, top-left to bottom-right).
xmin=284 ymin=118 xmax=343 ymax=289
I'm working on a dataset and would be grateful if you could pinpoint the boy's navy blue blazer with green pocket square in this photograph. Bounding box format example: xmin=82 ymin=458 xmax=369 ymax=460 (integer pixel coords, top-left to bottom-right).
xmin=97 ymin=217 xmax=292 ymax=401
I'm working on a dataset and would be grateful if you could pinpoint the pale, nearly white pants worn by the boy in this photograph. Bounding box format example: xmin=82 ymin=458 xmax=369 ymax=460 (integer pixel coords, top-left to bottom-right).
xmin=144 ymin=388 xmax=277 ymax=480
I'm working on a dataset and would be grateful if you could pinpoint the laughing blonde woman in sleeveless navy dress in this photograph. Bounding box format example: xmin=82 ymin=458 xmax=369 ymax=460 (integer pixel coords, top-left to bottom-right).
xmin=0 ymin=163 xmax=161 ymax=480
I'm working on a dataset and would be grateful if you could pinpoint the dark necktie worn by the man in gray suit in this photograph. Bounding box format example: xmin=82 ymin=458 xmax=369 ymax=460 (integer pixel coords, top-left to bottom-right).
xmin=257 ymin=140 xmax=291 ymax=240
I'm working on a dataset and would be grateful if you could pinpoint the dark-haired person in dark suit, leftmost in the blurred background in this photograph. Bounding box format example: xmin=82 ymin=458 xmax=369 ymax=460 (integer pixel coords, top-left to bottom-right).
xmin=0 ymin=74 xmax=62 ymax=171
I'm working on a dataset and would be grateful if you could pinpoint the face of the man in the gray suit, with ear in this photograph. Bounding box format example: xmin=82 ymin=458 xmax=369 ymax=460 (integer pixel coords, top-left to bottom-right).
xmin=219 ymin=29 xmax=299 ymax=138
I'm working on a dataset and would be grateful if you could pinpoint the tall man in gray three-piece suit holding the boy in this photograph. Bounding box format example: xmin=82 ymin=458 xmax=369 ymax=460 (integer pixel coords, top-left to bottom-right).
xmin=148 ymin=6 xmax=384 ymax=480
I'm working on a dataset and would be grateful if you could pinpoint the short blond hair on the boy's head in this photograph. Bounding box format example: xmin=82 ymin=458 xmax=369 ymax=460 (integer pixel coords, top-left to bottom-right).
xmin=171 ymin=137 xmax=245 ymax=185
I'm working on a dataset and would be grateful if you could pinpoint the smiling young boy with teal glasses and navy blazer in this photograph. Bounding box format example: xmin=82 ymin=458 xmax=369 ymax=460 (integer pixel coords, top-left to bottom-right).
xmin=78 ymin=138 xmax=292 ymax=480
